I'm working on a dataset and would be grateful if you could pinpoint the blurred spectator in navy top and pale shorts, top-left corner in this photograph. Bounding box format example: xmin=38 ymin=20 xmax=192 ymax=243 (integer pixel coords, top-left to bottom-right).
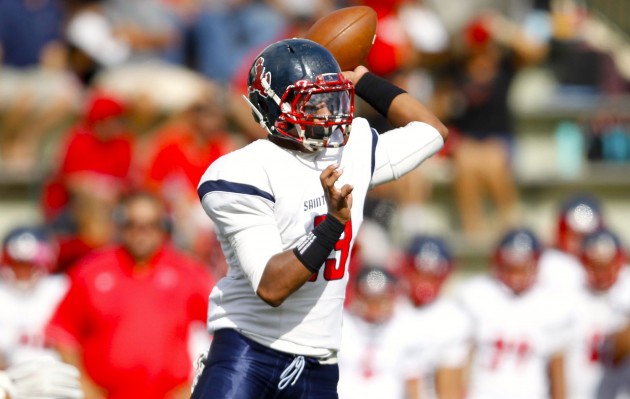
xmin=0 ymin=0 xmax=81 ymax=177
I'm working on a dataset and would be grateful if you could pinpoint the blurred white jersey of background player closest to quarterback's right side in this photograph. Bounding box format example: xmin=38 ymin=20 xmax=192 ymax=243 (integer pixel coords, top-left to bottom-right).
xmin=337 ymin=304 xmax=419 ymax=399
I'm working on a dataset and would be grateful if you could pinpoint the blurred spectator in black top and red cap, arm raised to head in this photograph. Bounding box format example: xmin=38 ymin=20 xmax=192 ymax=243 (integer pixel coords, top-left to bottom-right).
xmin=441 ymin=12 xmax=546 ymax=241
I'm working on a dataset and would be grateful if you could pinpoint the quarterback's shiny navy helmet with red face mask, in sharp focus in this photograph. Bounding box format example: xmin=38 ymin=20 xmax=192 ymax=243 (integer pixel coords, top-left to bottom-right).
xmin=247 ymin=39 xmax=354 ymax=152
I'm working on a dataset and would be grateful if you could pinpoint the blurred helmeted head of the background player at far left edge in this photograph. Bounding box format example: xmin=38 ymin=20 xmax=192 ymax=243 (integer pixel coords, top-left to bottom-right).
xmin=0 ymin=226 xmax=58 ymax=288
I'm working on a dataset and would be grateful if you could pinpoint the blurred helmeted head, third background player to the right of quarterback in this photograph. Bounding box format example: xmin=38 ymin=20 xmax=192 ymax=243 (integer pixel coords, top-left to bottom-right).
xmin=492 ymin=228 xmax=542 ymax=295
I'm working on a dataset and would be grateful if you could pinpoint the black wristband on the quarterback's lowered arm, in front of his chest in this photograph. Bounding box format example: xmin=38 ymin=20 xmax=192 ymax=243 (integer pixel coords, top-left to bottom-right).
xmin=293 ymin=214 xmax=346 ymax=273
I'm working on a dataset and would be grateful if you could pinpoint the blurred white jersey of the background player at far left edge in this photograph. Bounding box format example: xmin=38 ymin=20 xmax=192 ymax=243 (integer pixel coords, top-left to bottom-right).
xmin=0 ymin=275 xmax=68 ymax=364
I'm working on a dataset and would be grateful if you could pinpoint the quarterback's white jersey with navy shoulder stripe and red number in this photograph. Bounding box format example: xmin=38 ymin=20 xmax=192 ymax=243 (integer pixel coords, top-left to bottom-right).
xmin=198 ymin=118 xmax=443 ymax=356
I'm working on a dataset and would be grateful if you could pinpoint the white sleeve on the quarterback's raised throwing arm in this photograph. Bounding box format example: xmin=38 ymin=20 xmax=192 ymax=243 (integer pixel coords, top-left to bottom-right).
xmin=371 ymin=122 xmax=444 ymax=187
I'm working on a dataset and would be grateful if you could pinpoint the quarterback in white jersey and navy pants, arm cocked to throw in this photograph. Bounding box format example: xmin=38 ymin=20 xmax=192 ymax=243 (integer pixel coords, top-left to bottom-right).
xmin=193 ymin=39 xmax=448 ymax=399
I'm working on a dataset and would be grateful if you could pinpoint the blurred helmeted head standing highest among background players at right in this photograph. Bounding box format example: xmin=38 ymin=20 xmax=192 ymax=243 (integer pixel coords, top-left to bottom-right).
xmin=556 ymin=194 xmax=603 ymax=256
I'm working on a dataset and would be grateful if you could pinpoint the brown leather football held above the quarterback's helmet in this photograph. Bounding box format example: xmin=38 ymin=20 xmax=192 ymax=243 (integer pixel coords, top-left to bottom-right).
xmin=304 ymin=6 xmax=376 ymax=71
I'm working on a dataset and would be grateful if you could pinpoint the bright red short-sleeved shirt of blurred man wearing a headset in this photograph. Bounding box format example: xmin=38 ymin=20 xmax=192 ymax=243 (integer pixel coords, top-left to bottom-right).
xmin=47 ymin=246 xmax=213 ymax=399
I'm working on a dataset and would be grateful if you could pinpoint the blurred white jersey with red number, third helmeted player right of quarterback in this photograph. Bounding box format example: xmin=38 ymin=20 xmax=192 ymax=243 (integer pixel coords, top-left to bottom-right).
xmin=458 ymin=276 xmax=572 ymax=399
